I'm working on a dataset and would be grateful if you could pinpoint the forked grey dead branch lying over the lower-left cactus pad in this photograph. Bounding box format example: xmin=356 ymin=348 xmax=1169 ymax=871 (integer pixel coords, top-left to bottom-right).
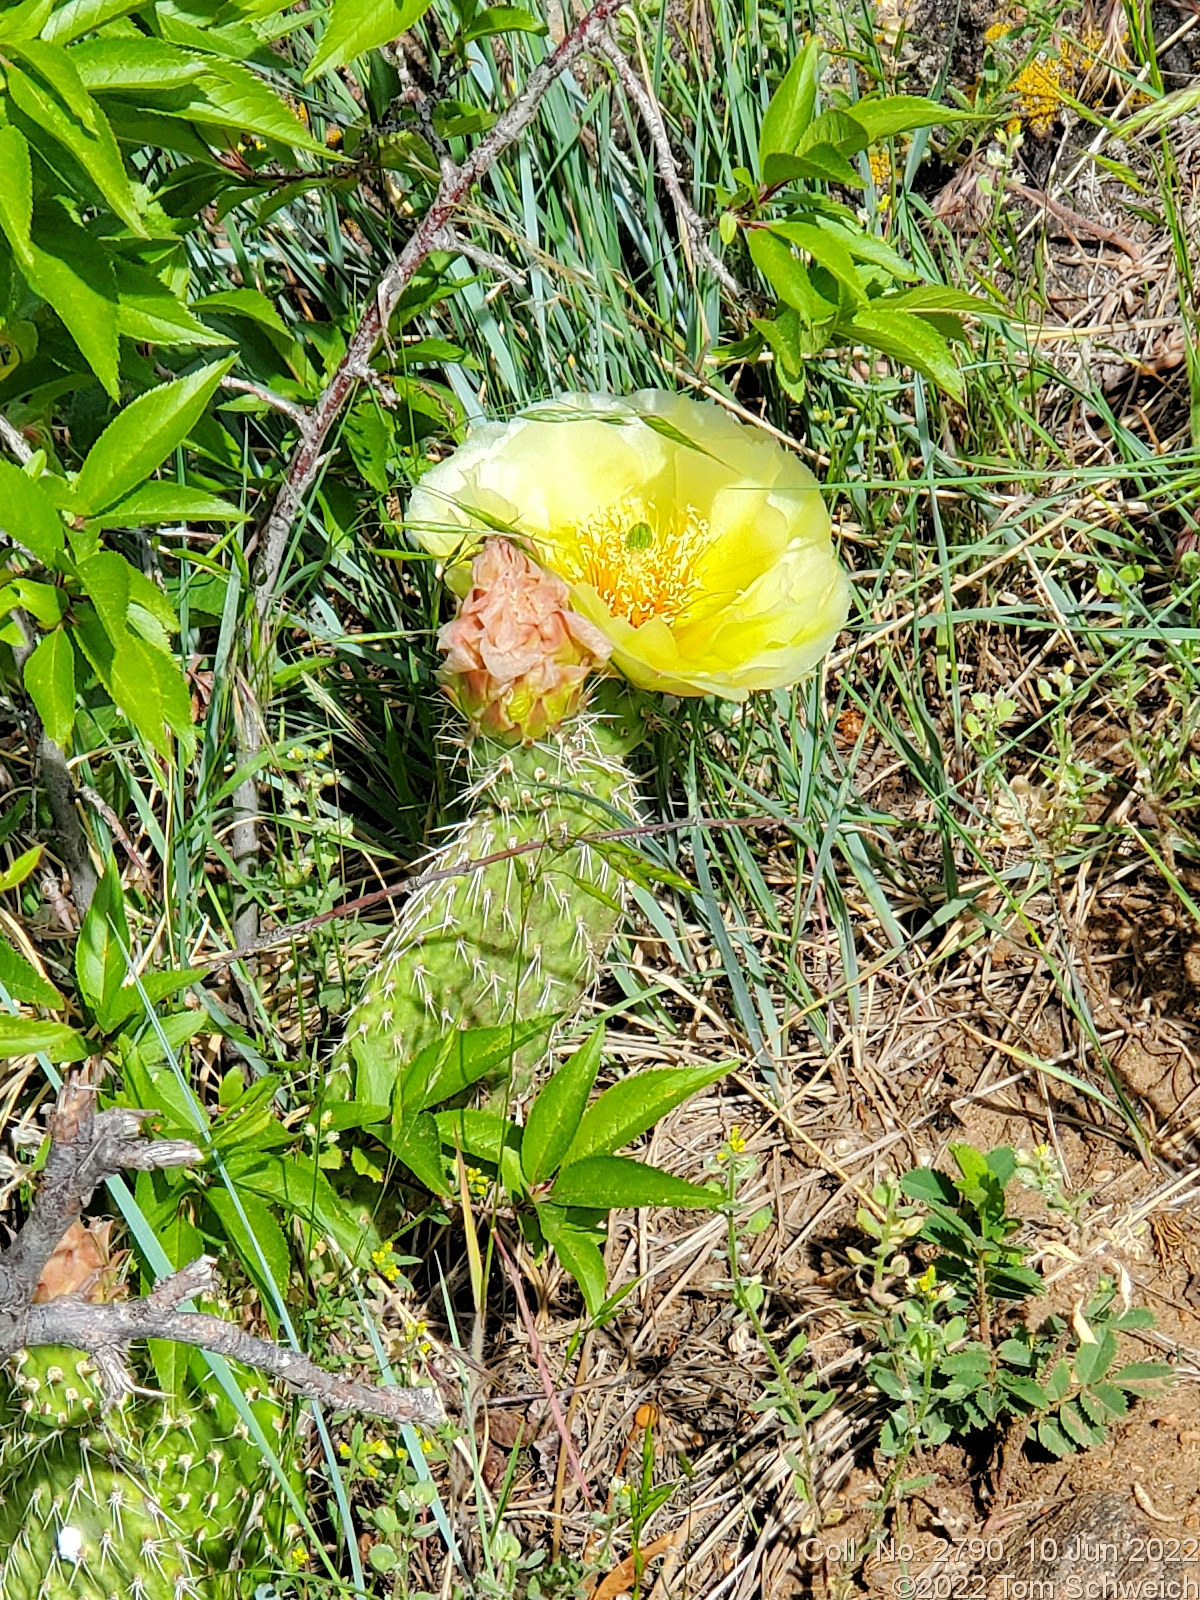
xmin=0 ymin=1080 xmax=443 ymax=1424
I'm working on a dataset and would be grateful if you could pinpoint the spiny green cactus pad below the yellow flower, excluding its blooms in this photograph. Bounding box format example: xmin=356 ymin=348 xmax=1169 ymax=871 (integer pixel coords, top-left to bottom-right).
xmin=346 ymin=714 xmax=635 ymax=1072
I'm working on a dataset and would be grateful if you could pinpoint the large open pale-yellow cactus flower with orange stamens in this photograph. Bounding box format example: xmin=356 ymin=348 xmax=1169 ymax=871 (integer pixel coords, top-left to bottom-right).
xmin=406 ymin=390 xmax=850 ymax=699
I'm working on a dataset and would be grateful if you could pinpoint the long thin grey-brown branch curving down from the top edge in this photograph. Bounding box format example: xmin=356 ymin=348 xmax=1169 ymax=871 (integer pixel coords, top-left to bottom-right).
xmin=230 ymin=0 xmax=624 ymax=946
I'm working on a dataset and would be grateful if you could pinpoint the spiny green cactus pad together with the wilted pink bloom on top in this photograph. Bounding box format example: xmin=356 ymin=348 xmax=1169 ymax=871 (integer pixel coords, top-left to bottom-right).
xmin=344 ymin=539 xmax=637 ymax=1074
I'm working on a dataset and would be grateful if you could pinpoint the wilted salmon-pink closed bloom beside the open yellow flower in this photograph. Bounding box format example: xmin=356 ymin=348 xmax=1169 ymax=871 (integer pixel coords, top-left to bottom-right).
xmin=437 ymin=539 xmax=613 ymax=741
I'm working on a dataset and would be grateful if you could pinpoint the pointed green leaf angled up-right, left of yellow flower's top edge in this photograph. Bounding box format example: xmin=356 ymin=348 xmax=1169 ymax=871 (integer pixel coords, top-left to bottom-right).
xmin=75 ymin=357 xmax=235 ymax=515
